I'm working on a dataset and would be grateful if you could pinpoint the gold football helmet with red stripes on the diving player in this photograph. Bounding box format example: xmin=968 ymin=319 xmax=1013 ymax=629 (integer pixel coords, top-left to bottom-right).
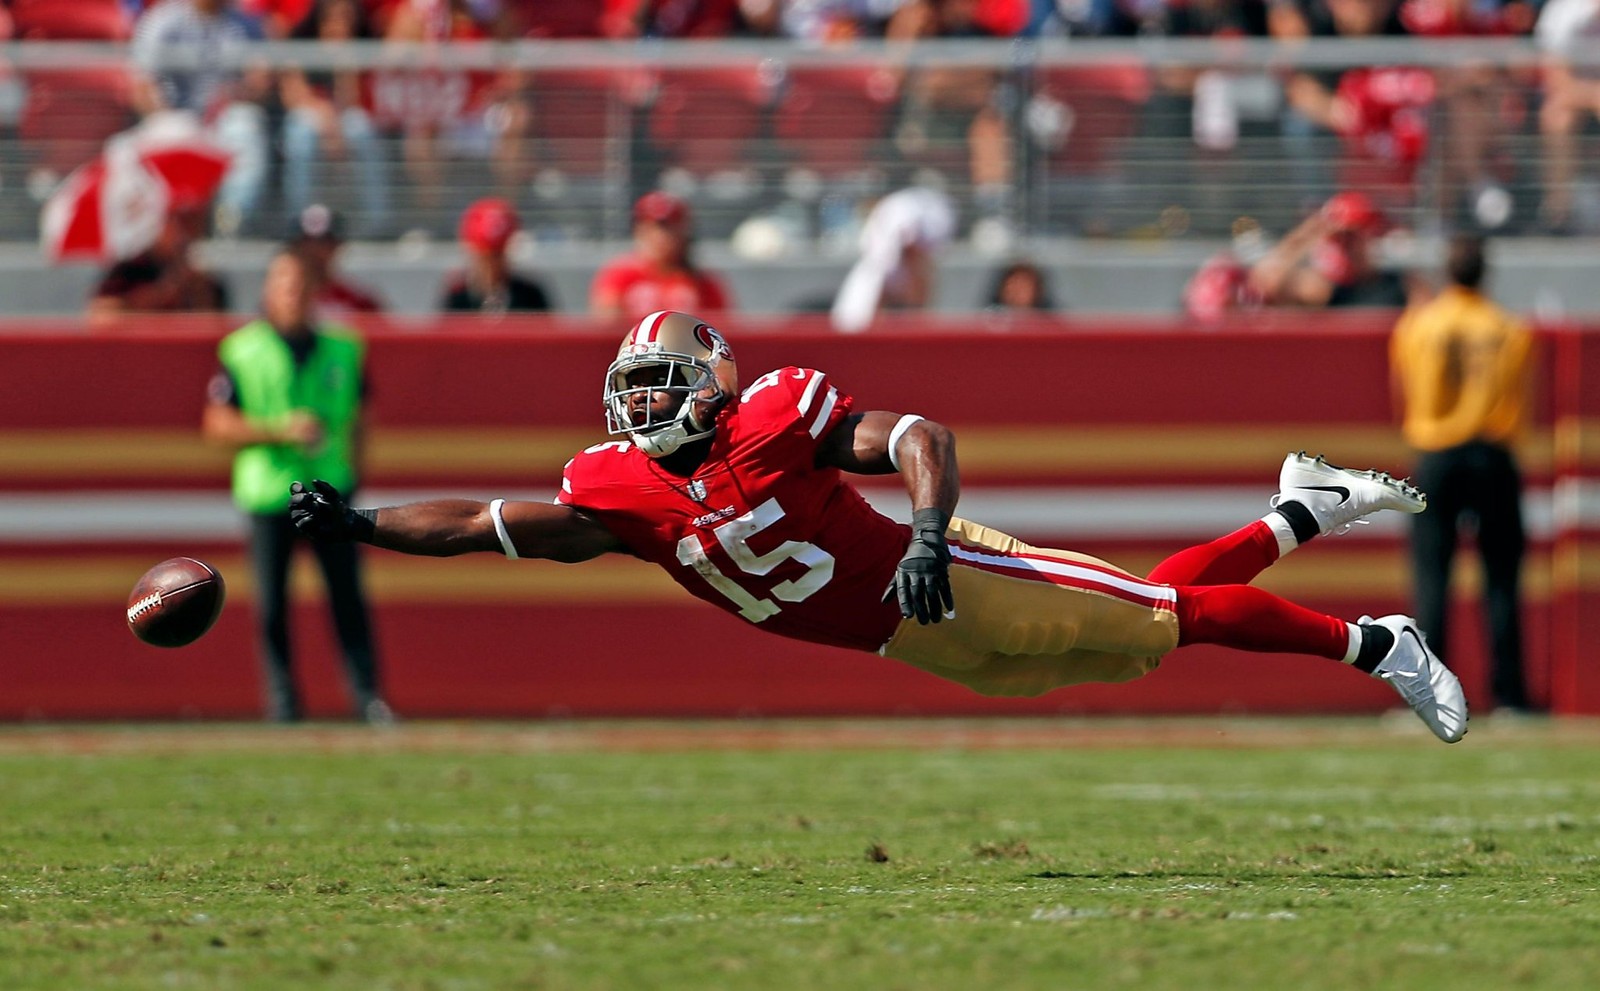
xmin=605 ymin=309 xmax=739 ymax=458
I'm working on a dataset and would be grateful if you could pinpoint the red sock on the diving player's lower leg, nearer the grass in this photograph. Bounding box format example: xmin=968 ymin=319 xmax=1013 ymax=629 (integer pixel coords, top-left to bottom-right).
xmin=1176 ymin=584 xmax=1350 ymax=661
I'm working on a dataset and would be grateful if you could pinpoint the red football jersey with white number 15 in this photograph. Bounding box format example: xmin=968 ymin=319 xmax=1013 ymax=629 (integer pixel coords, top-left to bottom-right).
xmin=557 ymin=368 xmax=910 ymax=650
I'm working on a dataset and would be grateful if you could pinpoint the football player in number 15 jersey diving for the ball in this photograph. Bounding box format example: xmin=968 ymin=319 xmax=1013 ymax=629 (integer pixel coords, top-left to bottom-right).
xmin=290 ymin=311 xmax=1467 ymax=743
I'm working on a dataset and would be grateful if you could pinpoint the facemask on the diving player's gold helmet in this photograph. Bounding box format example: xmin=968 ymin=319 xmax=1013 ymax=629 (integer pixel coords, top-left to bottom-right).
xmin=605 ymin=351 xmax=723 ymax=458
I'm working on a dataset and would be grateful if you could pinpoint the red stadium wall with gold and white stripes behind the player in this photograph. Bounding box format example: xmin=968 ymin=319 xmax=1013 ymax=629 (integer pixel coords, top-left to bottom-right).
xmin=0 ymin=315 xmax=1600 ymax=719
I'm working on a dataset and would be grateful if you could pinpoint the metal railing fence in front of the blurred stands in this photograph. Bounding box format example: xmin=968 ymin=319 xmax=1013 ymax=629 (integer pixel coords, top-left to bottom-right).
xmin=0 ymin=38 xmax=1600 ymax=248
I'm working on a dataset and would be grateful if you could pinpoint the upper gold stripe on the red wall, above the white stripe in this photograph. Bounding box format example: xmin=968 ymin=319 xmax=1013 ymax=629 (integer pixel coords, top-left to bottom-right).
xmin=0 ymin=419 xmax=1574 ymax=482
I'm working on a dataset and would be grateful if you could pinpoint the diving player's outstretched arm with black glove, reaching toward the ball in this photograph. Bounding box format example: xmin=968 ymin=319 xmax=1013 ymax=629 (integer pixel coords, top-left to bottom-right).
xmin=290 ymin=482 xmax=624 ymax=564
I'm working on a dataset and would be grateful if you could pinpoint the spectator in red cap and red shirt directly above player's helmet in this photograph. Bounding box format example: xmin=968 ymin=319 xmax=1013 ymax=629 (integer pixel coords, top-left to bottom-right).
xmin=589 ymin=191 xmax=730 ymax=328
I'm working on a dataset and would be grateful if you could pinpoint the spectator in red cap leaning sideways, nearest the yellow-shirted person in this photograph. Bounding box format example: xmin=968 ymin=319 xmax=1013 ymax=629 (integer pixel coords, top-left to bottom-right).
xmin=1250 ymin=192 xmax=1408 ymax=307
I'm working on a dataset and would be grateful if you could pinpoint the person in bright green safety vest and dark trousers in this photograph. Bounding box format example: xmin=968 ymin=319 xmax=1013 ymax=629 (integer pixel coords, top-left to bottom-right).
xmin=202 ymin=250 xmax=394 ymax=722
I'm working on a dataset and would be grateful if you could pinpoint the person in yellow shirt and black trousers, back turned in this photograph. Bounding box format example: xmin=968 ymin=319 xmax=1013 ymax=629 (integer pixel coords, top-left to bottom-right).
xmin=1389 ymin=237 xmax=1533 ymax=709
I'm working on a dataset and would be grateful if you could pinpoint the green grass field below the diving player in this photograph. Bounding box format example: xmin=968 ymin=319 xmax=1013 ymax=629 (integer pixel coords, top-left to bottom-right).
xmin=0 ymin=719 xmax=1600 ymax=991
